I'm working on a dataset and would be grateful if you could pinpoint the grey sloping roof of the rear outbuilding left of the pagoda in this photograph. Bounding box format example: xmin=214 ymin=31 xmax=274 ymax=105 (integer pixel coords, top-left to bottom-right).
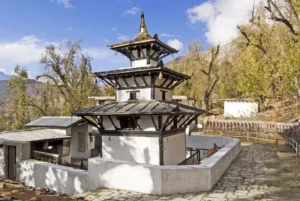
xmin=26 ymin=116 xmax=84 ymax=128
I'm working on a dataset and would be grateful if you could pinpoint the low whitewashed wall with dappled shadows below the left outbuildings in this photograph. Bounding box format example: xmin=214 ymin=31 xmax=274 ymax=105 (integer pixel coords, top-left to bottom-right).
xmin=18 ymin=160 xmax=93 ymax=195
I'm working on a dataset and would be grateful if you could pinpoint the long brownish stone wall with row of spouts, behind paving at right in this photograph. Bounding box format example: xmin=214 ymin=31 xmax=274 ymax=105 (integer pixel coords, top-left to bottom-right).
xmin=204 ymin=119 xmax=300 ymax=144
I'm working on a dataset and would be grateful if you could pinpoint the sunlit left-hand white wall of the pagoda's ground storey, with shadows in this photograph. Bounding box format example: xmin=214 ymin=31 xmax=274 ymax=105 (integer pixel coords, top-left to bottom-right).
xmin=102 ymin=136 xmax=159 ymax=165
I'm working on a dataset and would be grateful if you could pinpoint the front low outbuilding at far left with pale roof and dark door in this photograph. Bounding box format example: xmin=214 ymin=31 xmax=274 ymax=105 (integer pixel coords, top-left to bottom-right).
xmin=0 ymin=129 xmax=71 ymax=179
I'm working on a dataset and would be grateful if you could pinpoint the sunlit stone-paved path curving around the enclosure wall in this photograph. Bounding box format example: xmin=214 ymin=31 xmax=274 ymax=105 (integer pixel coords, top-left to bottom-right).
xmin=84 ymin=144 xmax=300 ymax=201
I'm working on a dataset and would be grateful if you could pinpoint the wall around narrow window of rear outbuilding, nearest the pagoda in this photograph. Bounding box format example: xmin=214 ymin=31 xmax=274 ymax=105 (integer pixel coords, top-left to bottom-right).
xmin=70 ymin=124 xmax=91 ymax=158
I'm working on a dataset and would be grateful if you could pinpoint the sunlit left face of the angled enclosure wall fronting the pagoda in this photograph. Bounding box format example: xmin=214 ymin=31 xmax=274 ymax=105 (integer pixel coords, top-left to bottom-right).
xmin=88 ymin=158 xmax=161 ymax=194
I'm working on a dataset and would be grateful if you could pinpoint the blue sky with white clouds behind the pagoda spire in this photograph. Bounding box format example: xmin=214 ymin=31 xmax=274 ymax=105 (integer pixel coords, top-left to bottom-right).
xmin=0 ymin=0 xmax=253 ymax=77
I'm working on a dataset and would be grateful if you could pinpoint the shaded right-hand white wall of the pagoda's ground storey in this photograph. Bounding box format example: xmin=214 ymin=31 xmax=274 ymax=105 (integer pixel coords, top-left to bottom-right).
xmin=163 ymin=132 xmax=186 ymax=165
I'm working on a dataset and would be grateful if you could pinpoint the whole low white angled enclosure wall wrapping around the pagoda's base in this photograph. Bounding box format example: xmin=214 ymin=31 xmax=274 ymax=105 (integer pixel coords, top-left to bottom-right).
xmin=88 ymin=136 xmax=241 ymax=195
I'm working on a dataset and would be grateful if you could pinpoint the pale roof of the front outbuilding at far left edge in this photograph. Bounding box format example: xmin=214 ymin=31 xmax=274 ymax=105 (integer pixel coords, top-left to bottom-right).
xmin=0 ymin=129 xmax=71 ymax=142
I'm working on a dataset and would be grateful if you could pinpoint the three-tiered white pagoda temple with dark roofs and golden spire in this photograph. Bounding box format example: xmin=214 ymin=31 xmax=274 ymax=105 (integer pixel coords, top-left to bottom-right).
xmin=73 ymin=13 xmax=205 ymax=165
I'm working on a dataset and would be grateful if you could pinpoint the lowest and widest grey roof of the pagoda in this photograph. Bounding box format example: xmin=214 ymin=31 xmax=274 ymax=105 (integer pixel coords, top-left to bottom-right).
xmin=73 ymin=100 xmax=205 ymax=116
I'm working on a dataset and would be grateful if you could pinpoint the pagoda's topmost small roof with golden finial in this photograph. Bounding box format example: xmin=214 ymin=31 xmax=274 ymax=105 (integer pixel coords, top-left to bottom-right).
xmin=108 ymin=12 xmax=178 ymax=61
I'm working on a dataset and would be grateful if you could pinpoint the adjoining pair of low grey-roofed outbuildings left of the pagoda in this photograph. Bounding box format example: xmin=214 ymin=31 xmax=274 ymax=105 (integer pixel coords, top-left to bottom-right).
xmin=0 ymin=116 xmax=100 ymax=179
